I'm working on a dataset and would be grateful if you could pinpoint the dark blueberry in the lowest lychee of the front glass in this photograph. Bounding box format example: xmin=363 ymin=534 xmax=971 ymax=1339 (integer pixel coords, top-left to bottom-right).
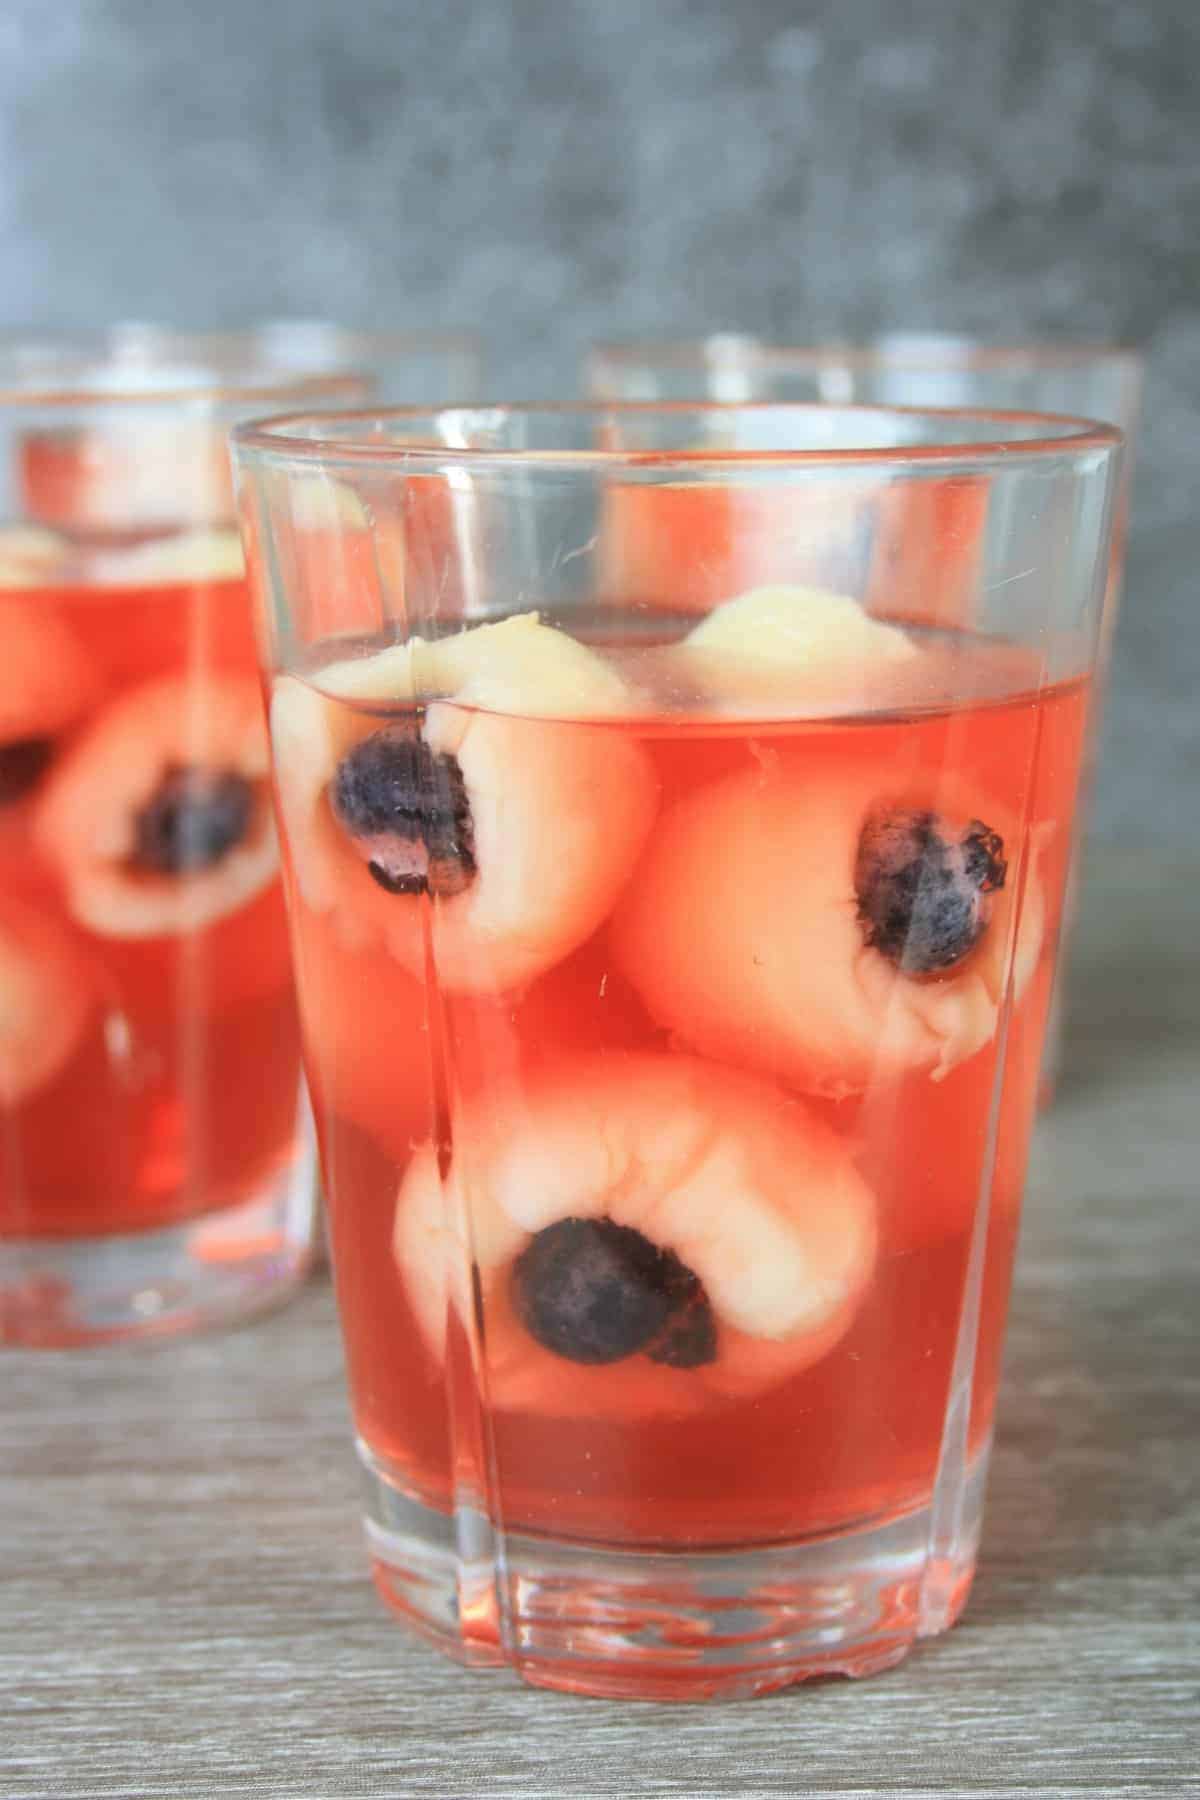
xmin=513 ymin=1219 xmax=716 ymax=1368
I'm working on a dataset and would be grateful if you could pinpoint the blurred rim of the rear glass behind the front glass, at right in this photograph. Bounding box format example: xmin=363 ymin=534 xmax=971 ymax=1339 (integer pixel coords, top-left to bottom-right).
xmin=587 ymin=331 xmax=1144 ymax=374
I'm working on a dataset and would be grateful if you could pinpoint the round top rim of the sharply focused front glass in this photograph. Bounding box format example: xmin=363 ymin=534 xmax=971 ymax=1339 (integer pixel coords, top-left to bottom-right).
xmin=230 ymin=400 xmax=1124 ymax=472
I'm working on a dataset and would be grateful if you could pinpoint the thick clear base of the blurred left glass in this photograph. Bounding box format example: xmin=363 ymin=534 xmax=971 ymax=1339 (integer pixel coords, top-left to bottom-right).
xmin=0 ymin=1130 xmax=317 ymax=1348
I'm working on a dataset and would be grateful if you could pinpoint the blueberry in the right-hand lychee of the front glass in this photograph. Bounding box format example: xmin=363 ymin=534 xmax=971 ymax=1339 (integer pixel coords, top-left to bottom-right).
xmin=855 ymin=810 xmax=1007 ymax=976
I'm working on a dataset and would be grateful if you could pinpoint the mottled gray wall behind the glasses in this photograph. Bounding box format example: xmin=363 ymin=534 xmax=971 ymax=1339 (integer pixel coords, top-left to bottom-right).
xmin=0 ymin=0 xmax=1200 ymax=844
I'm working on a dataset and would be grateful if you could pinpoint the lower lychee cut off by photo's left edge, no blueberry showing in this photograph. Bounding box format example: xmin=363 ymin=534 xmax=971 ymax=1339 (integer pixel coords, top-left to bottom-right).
xmin=0 ymin=896 xmax=95 ymax=1107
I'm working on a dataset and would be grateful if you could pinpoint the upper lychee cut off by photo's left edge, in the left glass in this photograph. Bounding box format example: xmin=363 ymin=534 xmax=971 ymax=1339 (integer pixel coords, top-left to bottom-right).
xmin=0 ymin=598 xmax=99 ymax=810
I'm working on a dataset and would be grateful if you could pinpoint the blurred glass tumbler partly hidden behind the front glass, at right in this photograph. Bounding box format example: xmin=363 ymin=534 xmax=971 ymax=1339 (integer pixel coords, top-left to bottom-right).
xmin=587 ymin=331 xmax=1142 ymax=1100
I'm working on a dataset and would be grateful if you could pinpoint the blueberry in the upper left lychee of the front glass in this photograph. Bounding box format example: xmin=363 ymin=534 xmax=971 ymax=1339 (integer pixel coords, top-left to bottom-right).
xmin=329 ymin=725 xmax=475 ymax=896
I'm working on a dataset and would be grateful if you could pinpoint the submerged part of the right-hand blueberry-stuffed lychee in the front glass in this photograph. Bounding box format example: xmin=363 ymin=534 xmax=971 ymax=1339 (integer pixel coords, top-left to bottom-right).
xmin=612 ymin=752 xmax=1040 ymax=1098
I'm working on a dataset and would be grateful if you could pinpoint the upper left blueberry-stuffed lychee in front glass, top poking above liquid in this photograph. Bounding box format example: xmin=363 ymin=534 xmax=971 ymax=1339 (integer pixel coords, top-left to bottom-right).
xmin=272 ymin=614 xmax=657 ymax=992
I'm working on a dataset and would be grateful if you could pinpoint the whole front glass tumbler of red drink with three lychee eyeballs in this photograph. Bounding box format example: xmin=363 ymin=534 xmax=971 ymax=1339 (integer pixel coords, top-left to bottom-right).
xmin=236 ymin=405 xmax=1119 ymax=1697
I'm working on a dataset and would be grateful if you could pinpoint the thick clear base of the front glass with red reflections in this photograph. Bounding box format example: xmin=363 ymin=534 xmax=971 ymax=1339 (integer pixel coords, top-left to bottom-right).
xmin=360 ymin=1444 xmax=986 ymax=1699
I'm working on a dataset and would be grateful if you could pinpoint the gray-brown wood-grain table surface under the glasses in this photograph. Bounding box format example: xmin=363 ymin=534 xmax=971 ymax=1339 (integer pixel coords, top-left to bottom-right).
xmin=0 ymin=853 xmax=1200 ymax=1800
